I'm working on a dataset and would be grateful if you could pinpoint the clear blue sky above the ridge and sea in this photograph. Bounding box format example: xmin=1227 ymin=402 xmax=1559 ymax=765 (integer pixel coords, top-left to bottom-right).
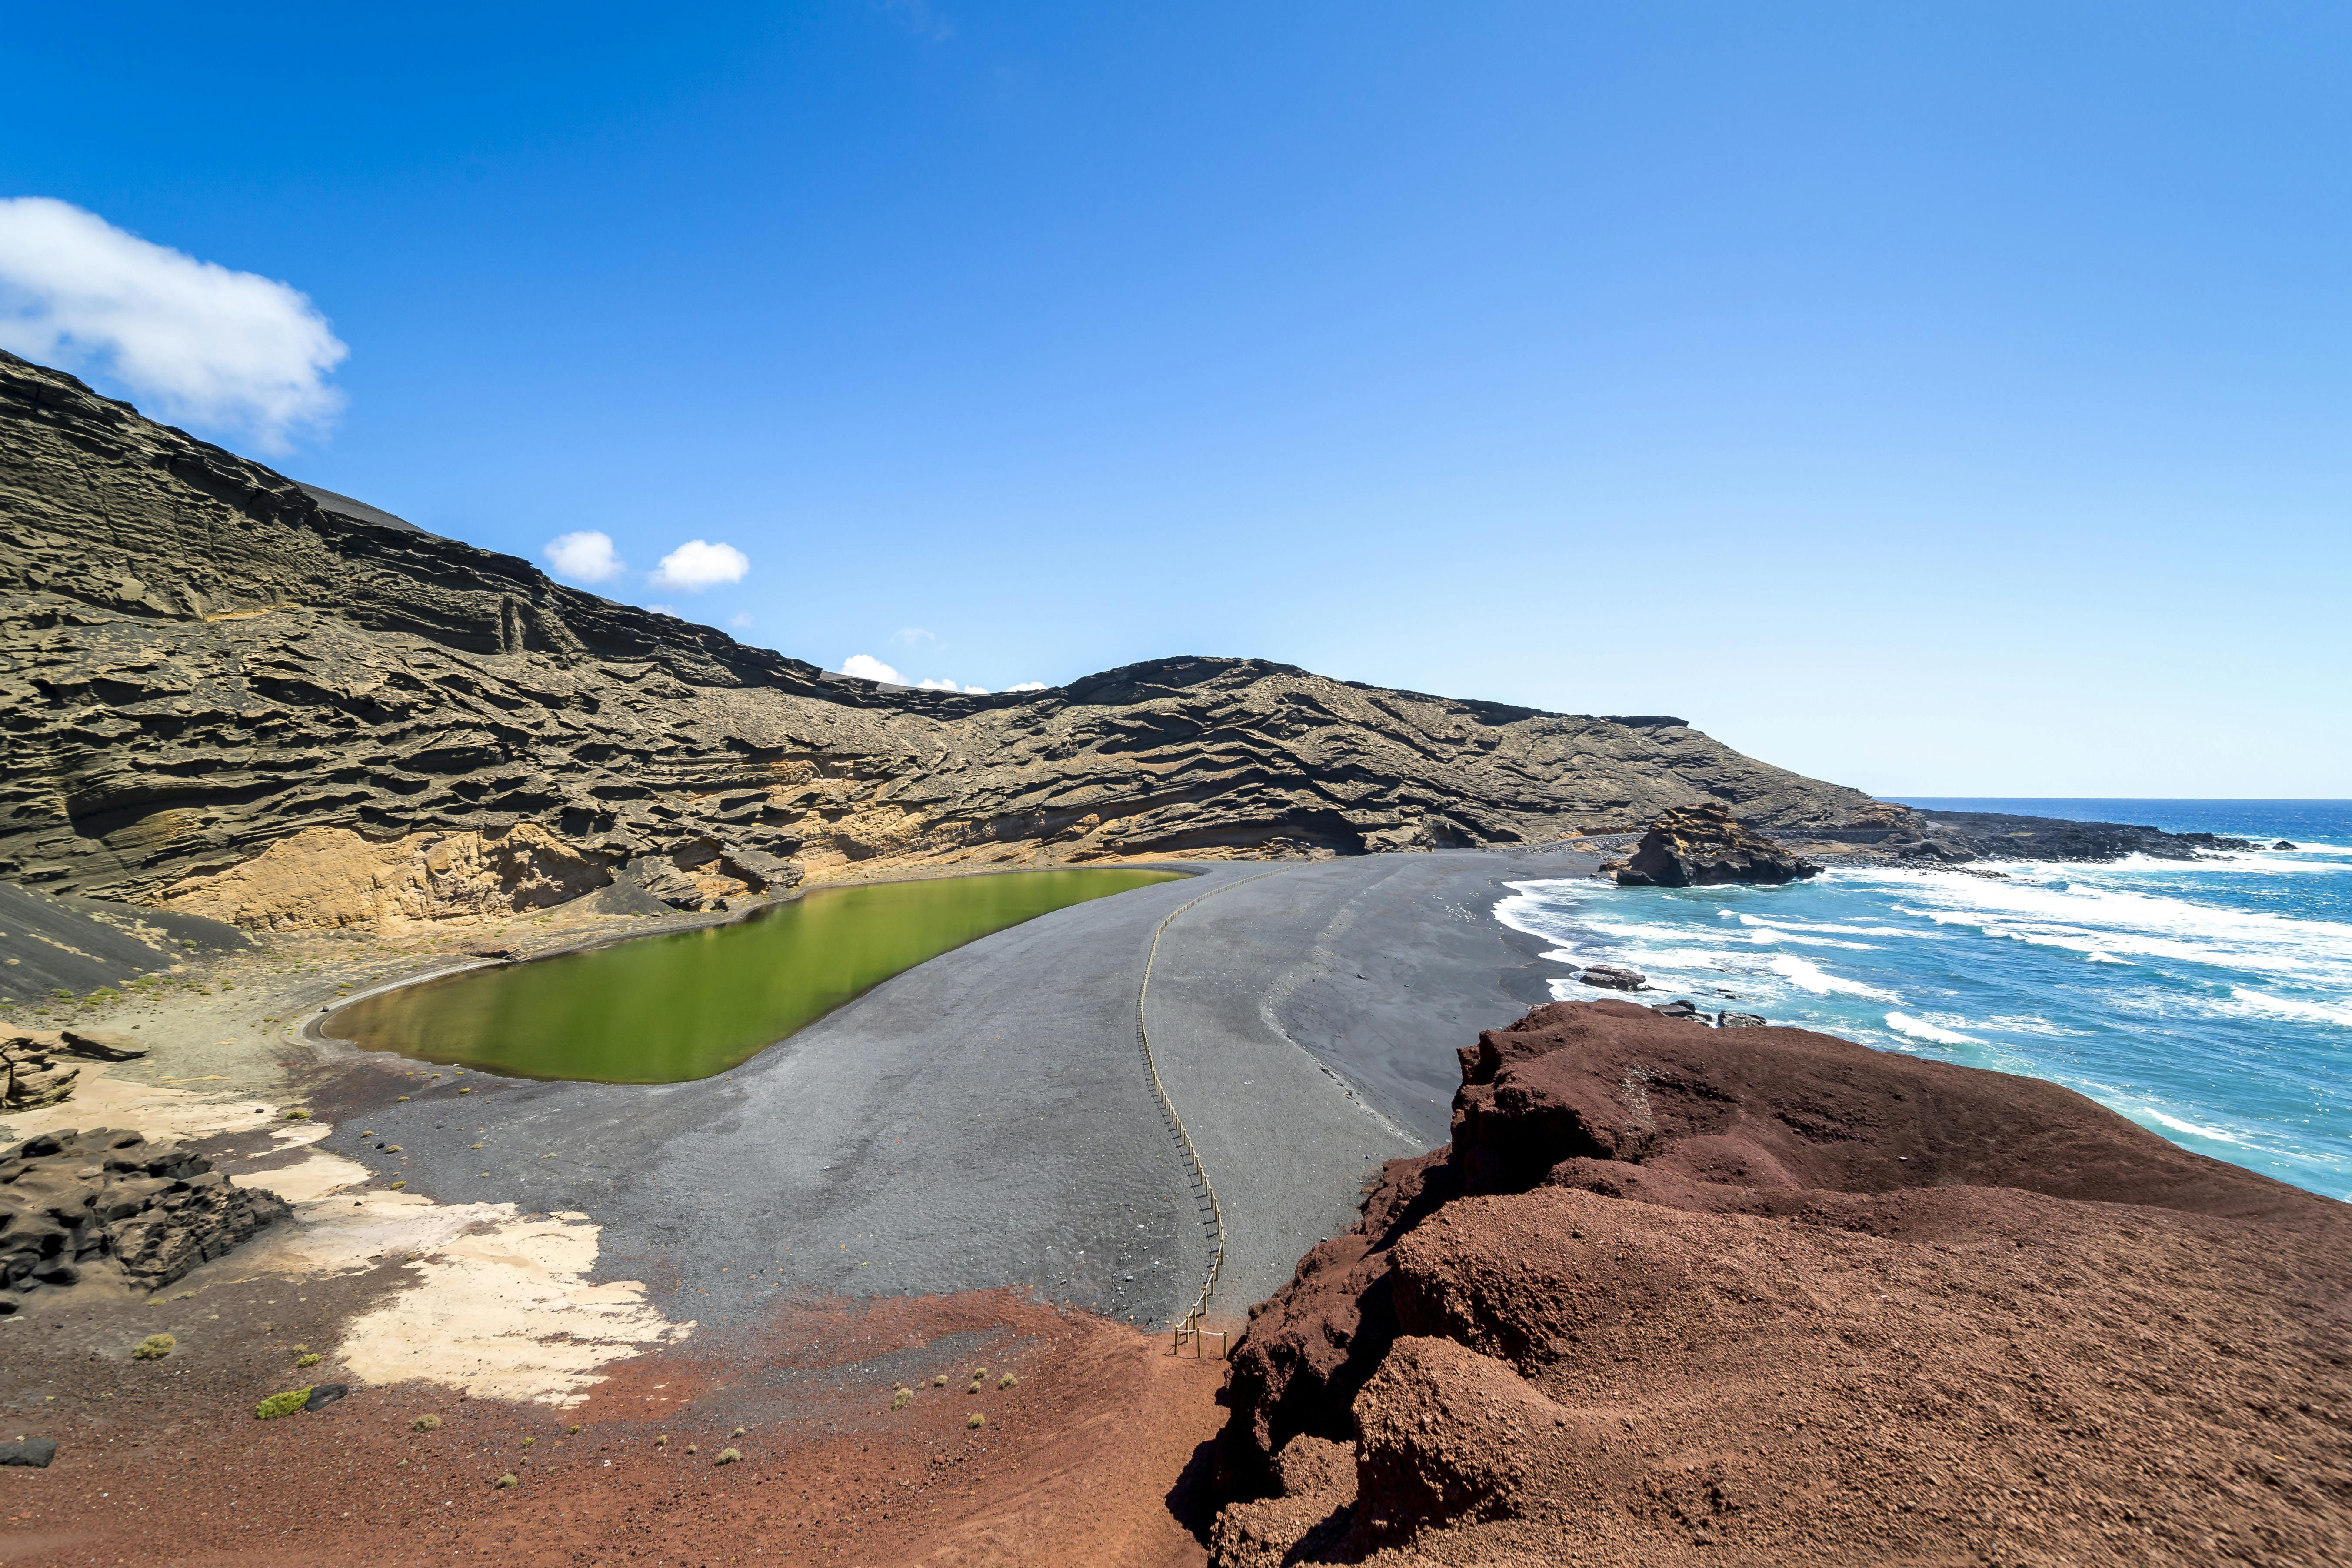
xmin=0 ymin=0 xmax=2352 ymax=797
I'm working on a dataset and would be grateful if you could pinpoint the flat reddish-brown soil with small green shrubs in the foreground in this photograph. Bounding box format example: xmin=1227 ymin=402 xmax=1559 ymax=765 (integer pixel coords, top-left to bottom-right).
xmin=0 ymin=1281 xmax=1223 ymax=1568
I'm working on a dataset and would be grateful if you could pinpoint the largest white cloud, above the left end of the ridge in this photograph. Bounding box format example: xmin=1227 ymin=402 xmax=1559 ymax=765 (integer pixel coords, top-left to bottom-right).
xmin=0 ymin=195 xmax=350 ymax=451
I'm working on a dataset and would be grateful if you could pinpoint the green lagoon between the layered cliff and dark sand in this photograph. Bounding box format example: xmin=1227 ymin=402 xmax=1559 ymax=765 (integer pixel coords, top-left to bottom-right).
xmin=325 ymin=870 xmax=1176 ymax=1084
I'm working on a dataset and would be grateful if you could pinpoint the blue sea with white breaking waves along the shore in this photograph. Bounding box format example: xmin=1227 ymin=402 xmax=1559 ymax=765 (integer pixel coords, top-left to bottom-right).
xmin=1496 ymin=799 xmax=2352 ymax=1199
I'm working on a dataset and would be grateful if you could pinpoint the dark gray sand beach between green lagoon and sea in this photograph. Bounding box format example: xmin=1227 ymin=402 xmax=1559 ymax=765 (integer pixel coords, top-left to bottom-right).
xmin=299 ymin=851 xmax=1595 ymax=1326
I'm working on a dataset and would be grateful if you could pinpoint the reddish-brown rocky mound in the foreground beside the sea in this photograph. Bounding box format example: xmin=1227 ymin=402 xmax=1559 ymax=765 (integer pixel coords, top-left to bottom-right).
xmin=1214 ymin=1002 xmax=2352 ymax=1568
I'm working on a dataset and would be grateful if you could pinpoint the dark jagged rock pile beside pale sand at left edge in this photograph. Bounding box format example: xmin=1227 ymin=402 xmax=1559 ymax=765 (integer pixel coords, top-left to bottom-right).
xmin=0 ymin=1129 xmax=292 ymax=1316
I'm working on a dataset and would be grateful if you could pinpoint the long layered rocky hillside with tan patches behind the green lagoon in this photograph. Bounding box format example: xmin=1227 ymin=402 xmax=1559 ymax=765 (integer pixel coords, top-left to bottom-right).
xmin=0 ymin=355 xmax=1900 ymax=929
